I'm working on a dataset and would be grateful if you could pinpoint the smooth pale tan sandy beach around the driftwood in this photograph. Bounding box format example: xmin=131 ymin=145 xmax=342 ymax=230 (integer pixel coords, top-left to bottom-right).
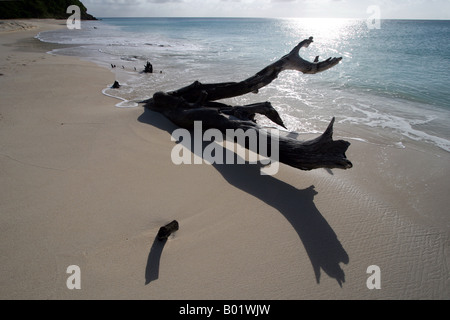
xmin=0 ymin=20 xmax=450 ymax=300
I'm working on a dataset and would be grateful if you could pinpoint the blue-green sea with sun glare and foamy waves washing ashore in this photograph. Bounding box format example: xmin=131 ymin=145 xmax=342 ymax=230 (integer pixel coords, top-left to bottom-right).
xmin=37 ymin=18 xmax=450 ymax=152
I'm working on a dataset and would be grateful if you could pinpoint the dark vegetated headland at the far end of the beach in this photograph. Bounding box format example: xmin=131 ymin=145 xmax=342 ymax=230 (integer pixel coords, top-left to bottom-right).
xmin=0 ymin=0 xmax=96 ymax=20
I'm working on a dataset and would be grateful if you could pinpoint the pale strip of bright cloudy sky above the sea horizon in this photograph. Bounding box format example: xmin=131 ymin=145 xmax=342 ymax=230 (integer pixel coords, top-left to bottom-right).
xmin=82 ymin=0 xmax=450 ymax=19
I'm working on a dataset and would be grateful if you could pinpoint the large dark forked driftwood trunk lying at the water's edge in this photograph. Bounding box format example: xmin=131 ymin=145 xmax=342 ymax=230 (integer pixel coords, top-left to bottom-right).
xmin=142 ymin=37 xmax=352 ymax=170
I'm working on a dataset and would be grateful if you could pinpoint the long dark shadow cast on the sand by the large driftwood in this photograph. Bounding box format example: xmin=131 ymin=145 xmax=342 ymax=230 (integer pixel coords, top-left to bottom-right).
xmin=138 ymin=110 xmax=349 ymax=286
